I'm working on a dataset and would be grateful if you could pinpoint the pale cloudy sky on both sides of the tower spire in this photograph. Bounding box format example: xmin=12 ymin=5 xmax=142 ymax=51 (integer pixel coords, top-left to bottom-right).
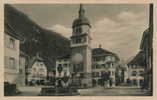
xmin=13 ymin=4 xmax=149 ymax=61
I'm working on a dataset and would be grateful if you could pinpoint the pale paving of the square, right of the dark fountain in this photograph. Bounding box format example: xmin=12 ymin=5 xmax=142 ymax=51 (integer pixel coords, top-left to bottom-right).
xmin=79 ymin=86 xmax=152 ymax=96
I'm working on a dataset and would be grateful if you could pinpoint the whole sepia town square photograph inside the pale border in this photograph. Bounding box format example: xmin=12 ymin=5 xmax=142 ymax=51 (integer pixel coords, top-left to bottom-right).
xmin=4 ymin=3 xmax=154 ymax=96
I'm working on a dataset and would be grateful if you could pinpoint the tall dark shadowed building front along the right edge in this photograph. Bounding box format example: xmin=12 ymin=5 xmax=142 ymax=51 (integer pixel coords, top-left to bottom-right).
xmin=140 ymin=4 xmax=153 ymax=92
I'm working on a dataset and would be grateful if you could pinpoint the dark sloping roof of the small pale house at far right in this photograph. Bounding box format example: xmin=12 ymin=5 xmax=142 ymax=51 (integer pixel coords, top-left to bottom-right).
xmin=127 ymin=51 xmax=146 ymax=66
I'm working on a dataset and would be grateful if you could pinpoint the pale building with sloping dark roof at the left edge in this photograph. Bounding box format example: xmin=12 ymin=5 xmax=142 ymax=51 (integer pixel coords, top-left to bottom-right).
xmin=4 ymin=20 xmax=22 ymax=85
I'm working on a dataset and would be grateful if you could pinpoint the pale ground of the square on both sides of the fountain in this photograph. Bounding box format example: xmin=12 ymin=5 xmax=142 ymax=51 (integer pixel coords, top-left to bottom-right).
xmin=18 ymin=86 xmax=149 ymax=96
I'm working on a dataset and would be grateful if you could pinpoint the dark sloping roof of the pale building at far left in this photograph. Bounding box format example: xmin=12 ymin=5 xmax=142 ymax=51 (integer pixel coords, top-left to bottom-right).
xmin=4 ymin=20 xmax=23 ymax=40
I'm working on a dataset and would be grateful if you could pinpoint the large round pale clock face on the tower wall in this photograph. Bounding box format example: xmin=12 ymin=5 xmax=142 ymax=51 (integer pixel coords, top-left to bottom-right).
xmin=71 ymin=53 xmax=83 ymax=64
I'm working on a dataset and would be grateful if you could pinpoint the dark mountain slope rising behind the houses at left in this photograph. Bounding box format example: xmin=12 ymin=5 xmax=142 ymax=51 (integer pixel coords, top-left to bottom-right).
xmin=4 ymin=4 xmax=70 ymax=69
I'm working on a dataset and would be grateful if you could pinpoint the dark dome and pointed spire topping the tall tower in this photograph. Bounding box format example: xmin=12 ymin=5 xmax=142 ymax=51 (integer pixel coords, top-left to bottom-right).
xmin=72 ymin=4 xmax=91 ymax=28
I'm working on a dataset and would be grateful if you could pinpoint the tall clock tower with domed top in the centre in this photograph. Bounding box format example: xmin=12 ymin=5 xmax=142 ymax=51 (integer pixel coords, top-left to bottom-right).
xmin=70 ymin=4 xmax=92 ymax=87
